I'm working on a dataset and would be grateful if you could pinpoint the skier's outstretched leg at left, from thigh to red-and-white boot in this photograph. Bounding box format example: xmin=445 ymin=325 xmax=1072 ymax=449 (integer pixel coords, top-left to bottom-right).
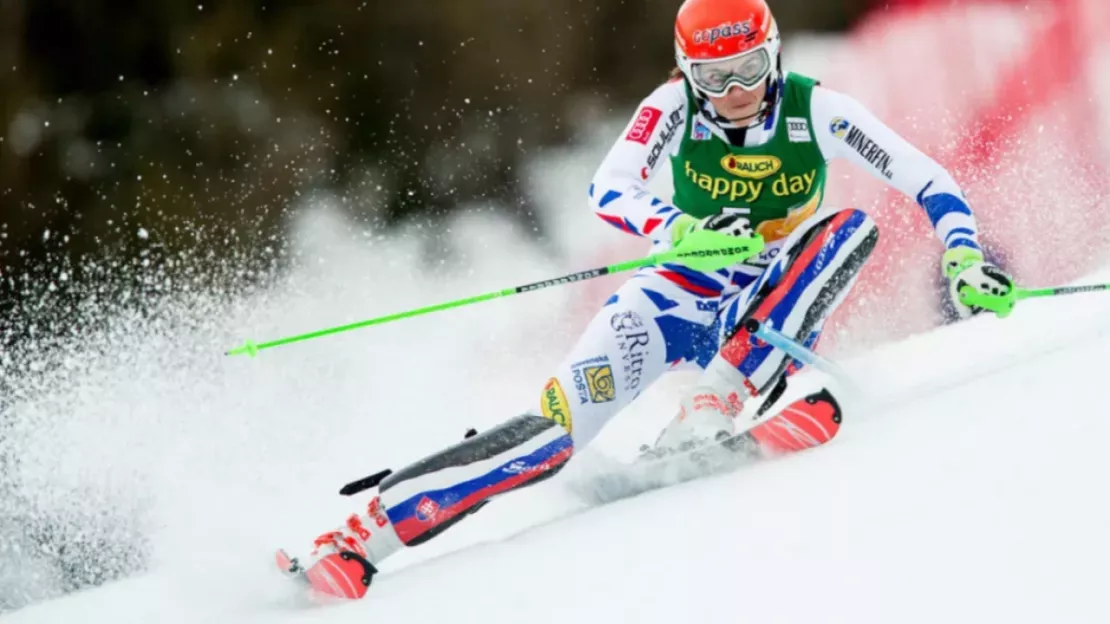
xmin=280 ymin=265 xmax=727 ymax=597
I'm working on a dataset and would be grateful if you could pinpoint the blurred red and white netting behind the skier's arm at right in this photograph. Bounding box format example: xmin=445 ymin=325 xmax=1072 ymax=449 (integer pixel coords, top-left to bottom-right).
xmin=821 ymin=0 xmax=1110 ymax=349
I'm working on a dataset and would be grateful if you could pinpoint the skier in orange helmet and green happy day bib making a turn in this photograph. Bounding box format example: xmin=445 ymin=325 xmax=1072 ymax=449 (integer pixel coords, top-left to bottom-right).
xmin=278 ymin=0 xmax=1012 ymax=598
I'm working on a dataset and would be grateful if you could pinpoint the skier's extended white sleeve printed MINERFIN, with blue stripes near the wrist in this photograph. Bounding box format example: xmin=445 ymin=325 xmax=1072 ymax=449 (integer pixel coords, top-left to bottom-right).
xmin=810 ymin=87 xmax=979 ymax=250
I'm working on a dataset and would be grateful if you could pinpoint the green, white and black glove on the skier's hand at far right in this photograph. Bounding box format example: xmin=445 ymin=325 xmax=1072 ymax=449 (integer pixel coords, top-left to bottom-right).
xmin=941 ymin=246 xmax=1015 ymax=319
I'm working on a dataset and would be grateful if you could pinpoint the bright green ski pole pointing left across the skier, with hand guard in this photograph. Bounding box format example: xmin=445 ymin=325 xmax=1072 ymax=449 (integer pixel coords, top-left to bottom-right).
xmin=224 ymin=230 xmax=764 ymax=358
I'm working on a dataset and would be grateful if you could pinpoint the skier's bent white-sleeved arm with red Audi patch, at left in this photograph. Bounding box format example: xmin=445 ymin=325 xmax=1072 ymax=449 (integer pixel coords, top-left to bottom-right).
xmin=589 ymin=82 xmax=686 ymax=240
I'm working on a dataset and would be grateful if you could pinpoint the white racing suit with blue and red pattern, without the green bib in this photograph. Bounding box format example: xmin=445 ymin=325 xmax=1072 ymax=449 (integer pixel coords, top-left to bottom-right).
xmin=542 ymin=73 xmax=979 ymax=449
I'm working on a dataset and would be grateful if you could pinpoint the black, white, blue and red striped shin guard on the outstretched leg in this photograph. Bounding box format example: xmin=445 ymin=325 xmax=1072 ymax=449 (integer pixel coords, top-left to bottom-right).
xmin=379 ymin=414 xmax=574 ymax=546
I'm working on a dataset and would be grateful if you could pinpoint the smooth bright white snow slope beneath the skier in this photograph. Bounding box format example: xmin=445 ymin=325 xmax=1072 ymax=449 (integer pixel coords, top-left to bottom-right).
xmin=4 ymin=245 xmax=1110 ymax=624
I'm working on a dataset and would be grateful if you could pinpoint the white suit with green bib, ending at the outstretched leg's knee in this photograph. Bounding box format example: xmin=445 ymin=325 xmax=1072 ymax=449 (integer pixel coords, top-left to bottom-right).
xmin=541 ymin=74 xmax=979 ymax=449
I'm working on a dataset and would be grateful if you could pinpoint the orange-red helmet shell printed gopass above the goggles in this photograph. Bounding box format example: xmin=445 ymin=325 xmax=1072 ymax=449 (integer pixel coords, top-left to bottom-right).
xmin=675 ymin=0 xmax=778 ymax=62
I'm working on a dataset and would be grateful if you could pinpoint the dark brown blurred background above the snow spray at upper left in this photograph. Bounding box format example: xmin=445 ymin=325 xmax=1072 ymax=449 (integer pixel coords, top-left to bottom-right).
xmin=0 ymin=0 xmax=869 ymax=314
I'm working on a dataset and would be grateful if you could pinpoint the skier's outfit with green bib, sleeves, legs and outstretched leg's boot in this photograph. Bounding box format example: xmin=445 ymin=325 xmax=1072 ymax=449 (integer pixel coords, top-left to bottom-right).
xmin=286 ymin=73 xmax=979 ymax=586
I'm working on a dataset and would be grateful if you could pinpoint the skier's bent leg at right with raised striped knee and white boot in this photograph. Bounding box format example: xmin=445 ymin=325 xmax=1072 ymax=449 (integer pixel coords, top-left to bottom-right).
xmin=657 ymin=209 xmax=878 ymax=446
